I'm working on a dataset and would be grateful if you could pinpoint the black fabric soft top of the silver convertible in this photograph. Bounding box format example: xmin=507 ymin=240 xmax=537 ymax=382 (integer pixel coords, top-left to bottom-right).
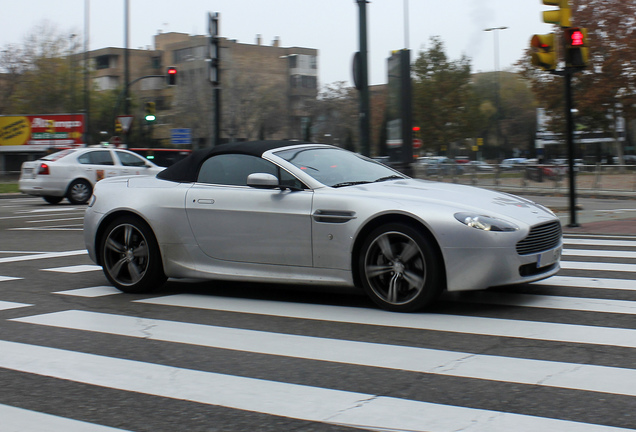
xmin=157 ymin=141 xmax=307 ymax=183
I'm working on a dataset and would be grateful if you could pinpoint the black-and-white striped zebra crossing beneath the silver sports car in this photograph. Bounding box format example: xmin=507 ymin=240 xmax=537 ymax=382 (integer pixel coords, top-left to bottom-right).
xmin=0 ymin=236 xmax=636 ymax=432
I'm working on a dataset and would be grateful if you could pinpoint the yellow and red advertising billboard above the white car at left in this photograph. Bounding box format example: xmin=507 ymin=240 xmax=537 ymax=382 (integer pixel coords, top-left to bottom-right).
xmin=0 ymin=114 xmax=85 ymax=151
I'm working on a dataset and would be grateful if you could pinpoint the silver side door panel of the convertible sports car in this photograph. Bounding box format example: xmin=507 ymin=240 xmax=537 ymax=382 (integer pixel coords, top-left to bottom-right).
xmin=186 ymin=183 xmax=313 ymax=266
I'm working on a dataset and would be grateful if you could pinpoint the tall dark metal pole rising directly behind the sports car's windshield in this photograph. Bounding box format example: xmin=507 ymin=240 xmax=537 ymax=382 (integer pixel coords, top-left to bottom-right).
xmin=357 ymin=0 xmax=371 ymax=156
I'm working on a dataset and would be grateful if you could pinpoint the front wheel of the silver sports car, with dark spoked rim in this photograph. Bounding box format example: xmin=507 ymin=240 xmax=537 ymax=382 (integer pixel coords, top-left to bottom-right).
xmin=358 ymin=223 xmax=444 ymax=312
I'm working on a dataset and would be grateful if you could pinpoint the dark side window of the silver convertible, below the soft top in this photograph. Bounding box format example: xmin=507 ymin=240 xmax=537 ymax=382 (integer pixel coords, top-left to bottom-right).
xmin=197 ymin=154 xmax=278 ymax=186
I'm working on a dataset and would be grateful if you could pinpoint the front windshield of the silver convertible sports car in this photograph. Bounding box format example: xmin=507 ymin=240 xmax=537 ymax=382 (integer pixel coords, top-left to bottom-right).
xmin=276 ymin=147 xmax=405 ymax=187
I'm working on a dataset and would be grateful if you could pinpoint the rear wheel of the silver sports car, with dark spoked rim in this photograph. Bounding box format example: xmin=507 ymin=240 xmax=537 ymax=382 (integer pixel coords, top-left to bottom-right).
xmin=99 ymin=216 xmax=166 ymax=293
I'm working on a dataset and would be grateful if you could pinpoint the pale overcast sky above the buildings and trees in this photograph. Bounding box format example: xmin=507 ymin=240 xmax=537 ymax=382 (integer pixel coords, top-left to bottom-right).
xmin=0 ymin=0 xmax=554 ymax=85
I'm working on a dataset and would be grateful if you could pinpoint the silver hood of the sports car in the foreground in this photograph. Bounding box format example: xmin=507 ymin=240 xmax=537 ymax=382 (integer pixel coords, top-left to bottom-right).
xmin=341 ymin=179 xmax=556 ymax=225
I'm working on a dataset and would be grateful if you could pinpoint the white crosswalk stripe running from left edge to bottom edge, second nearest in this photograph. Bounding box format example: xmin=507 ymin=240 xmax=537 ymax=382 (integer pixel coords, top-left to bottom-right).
xmin=0 ymin=341 xmax=633 ymax=432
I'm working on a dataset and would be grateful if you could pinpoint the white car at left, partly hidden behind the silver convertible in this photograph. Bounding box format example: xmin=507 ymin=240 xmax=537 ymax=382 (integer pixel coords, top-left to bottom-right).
xmin=19 ymin=147 xmax=164 ymax=204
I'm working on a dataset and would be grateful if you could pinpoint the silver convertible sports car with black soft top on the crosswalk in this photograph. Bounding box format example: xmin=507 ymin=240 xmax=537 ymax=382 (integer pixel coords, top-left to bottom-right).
xmin=84 ymin=141 xmax=562 ymax=311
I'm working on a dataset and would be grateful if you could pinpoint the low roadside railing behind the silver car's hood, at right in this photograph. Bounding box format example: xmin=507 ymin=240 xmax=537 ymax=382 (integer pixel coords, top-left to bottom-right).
xmin=413 ymin=164 xmax=636 ymax=198
